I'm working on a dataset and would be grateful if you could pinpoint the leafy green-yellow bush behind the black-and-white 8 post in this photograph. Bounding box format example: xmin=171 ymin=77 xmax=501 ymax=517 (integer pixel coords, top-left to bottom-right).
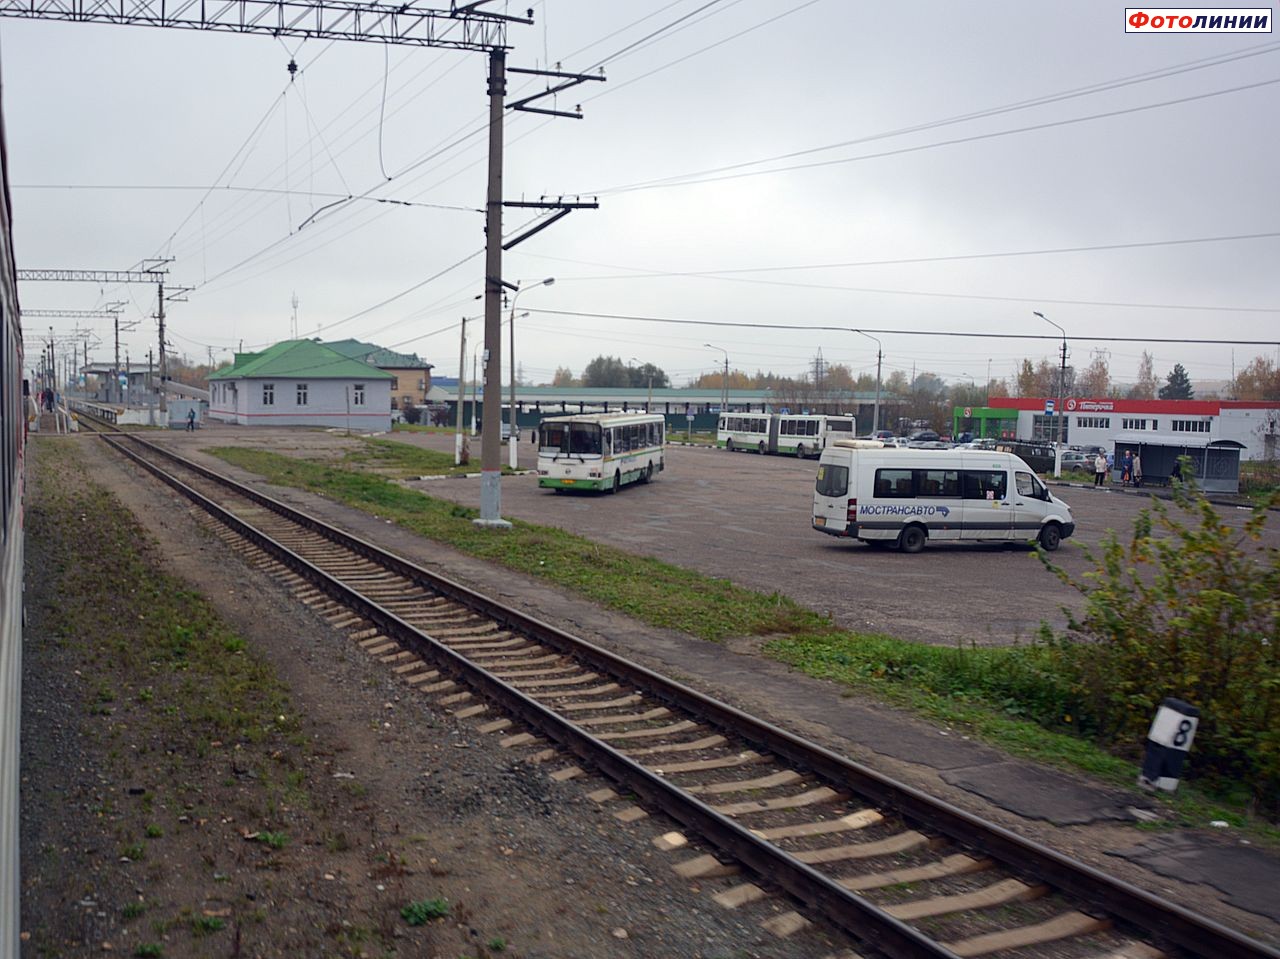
xmin=1041 ymin=472 xmax=1280 ymax=818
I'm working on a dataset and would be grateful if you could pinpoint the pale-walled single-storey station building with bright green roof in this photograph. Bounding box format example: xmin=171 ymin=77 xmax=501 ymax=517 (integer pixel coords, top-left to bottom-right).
xmin=209 ymin=339 xmax=396 ymax=431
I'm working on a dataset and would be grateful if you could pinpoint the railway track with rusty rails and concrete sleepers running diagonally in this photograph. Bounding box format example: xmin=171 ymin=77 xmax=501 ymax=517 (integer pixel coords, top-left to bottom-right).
xmin=80 ymin=422 xmax=1280 ymax=959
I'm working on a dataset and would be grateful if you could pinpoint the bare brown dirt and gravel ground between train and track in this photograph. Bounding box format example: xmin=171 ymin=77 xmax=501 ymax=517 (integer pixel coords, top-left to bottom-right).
xmin=22 ymin=438 xmax=842 ymax=959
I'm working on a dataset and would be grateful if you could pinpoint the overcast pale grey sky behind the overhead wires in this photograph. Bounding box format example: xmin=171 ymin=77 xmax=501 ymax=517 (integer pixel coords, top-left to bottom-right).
xmin=0 ymin=0 xmax=1280 ymax=384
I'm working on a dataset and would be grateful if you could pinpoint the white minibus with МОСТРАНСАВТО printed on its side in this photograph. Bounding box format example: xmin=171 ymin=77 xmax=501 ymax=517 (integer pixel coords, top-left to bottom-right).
xmin=813 ymin=440 xmax=1075 ymax=553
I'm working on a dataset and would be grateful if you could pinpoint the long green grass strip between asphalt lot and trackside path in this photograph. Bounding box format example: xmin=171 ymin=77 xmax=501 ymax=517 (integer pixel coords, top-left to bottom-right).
xmin=210 ymin=447 xmax=1280 ymax=839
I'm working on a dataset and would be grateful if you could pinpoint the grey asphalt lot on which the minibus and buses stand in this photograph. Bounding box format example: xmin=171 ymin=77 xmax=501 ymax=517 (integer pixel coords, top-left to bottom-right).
xmin=396 ymin=434 xmax=1280 ymax=644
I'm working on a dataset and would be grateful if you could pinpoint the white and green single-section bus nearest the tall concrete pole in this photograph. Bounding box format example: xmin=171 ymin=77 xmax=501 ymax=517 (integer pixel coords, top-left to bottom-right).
xmin=538 ymin=412 xmax=667 ymax=493
